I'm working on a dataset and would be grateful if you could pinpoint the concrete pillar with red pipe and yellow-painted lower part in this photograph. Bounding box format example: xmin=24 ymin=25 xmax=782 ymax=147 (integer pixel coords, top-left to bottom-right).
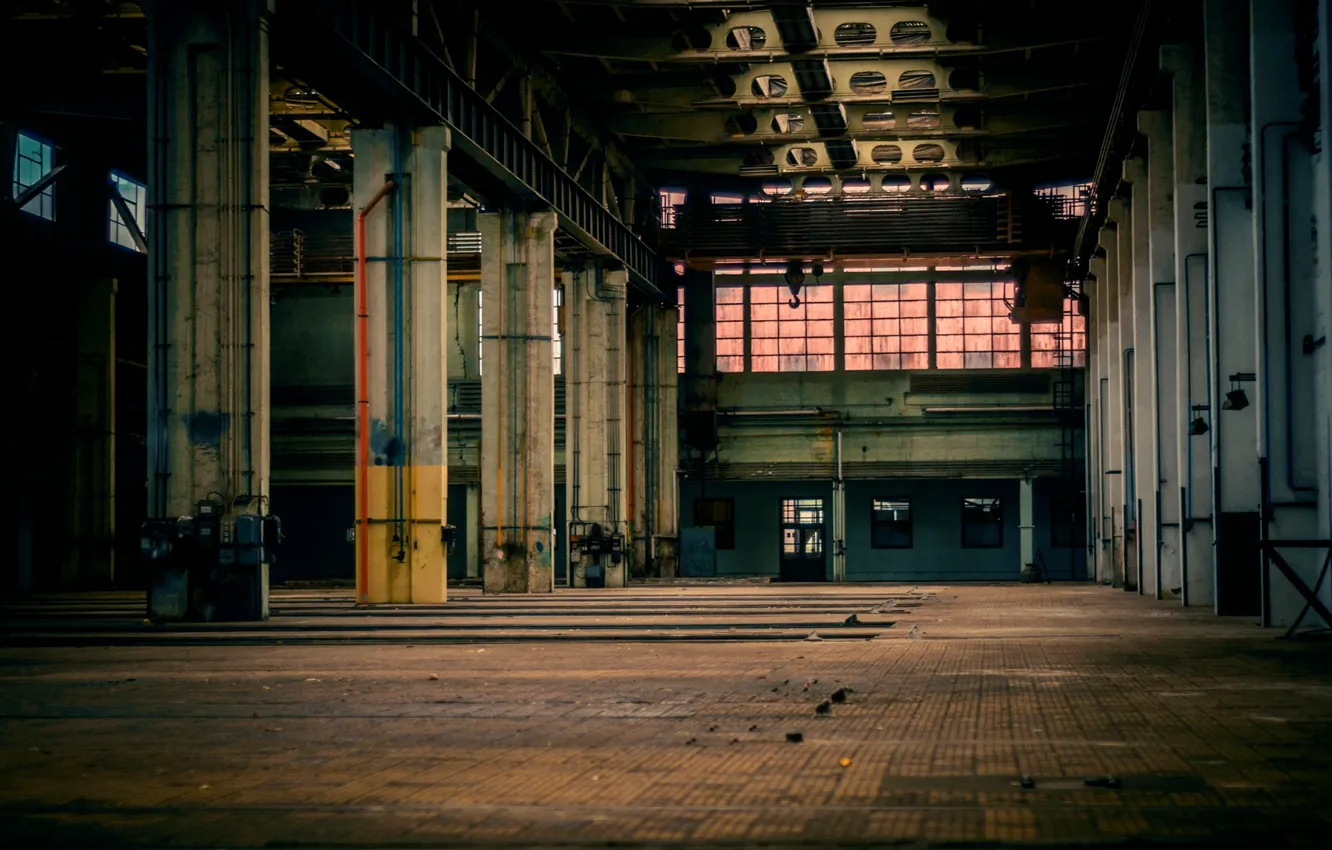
xmin=352 ymin=127 xmax=449 ymax=604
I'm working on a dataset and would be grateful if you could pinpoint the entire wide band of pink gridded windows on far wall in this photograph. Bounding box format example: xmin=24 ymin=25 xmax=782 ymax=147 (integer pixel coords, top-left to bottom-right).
xmin=679 ymin=266 xmax=1087 ymax=373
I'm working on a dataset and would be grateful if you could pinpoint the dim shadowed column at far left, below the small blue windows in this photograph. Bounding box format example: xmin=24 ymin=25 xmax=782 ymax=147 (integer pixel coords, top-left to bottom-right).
xmin=61 ymin=280 xmax=116 ymax=588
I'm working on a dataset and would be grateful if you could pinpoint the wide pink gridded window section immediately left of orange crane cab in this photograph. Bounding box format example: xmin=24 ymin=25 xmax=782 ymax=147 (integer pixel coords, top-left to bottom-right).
xmin=934 ymin=281 xmax=1022 ymax=369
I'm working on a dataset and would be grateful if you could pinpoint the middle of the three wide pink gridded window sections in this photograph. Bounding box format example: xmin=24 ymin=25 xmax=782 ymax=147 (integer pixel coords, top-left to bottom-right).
xmin=842 ymin=284 xmax=930 ymax=370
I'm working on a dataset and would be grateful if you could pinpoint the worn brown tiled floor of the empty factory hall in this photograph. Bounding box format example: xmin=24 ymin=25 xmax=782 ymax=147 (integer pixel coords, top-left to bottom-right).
xmin=0 ymin=585 xmax=1332 ymax=847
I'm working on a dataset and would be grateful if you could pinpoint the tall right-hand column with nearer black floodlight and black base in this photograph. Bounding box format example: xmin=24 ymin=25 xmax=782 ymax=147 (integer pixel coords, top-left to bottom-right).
xmin=1203 ymin=0 xmax=1260 ymax=614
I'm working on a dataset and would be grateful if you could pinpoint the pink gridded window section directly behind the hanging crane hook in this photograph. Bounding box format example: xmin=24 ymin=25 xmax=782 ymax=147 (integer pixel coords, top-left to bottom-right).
xmin=750 ymin=284 xmax=834 ymax=372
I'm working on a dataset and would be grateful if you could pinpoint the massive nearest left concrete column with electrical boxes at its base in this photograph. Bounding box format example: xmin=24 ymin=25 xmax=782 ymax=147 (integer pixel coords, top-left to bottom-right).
xmin=145 ymin=0 xmax=273 ymax=617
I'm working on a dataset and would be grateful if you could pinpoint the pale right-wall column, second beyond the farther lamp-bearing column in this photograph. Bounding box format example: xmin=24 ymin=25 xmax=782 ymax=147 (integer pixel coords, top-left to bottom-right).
xmin=1124 ymin=159 xmax=1159 ymax=596
